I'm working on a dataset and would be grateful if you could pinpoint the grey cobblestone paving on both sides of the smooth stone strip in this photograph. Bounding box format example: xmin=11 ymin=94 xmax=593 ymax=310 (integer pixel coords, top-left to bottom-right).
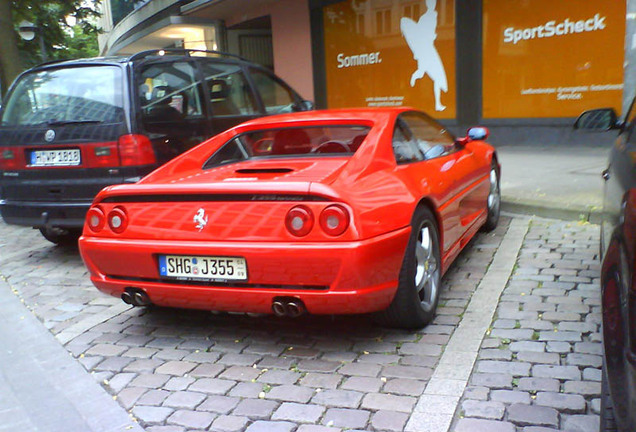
xmin=0 ymin=218 xmax=600 ymax=432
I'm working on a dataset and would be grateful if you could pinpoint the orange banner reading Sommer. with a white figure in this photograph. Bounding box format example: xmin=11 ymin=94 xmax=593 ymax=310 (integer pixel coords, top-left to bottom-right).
xmin=323 ymin=0 xmax=456 ymax=118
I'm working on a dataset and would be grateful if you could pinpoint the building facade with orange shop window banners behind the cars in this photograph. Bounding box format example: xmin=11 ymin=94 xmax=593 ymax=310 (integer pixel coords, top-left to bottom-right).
xmin=100 ymin=0 xmax=636 ymax=142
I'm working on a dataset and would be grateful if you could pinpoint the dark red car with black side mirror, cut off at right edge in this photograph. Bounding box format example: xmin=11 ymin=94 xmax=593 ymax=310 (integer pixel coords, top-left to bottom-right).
xmin=575 ymin=102 xmax=636 ymax=432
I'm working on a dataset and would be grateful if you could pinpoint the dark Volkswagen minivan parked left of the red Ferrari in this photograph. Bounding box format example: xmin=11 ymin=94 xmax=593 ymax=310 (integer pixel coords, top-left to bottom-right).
xmin=0 ymin=49 xmax=313 ymax=243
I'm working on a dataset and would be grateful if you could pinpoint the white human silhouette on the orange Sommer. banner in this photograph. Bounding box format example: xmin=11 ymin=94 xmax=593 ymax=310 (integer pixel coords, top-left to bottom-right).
xmin=400 ymin=0 xmax=448 ymax=111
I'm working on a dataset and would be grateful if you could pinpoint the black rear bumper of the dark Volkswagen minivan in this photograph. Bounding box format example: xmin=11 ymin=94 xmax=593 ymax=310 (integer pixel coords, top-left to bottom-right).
xmin=0 ymin=200 xmax=92 ymax=228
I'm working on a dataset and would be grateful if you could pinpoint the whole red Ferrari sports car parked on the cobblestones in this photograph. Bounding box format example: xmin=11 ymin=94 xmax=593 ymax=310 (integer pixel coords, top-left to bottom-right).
xmin=79 ymin=108 xmax=500 ymax=328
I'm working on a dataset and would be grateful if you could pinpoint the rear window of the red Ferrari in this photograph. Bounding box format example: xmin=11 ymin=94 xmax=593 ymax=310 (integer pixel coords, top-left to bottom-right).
xmin=203 ymin=126 xmax=370 ymax=168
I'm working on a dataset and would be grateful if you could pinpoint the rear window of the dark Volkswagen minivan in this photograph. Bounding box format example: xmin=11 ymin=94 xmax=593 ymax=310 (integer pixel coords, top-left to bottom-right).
xmin=2 ymin=66 xmax=123 ymax=126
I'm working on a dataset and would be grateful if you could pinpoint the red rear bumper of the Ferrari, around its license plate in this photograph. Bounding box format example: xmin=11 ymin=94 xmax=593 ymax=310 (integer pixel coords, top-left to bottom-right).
xmin=79 ymin=227 xmax=410 ymax=314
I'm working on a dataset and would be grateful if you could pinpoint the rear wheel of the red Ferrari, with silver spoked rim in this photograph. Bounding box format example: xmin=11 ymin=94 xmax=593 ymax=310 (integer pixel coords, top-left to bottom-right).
xmin=378 ymin=207 xmax=442 ymax=329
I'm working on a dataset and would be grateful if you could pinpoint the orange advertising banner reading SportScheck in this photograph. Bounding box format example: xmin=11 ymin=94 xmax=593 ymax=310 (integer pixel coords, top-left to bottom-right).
xmin=483 ymin=0 xmax=626 ymax=118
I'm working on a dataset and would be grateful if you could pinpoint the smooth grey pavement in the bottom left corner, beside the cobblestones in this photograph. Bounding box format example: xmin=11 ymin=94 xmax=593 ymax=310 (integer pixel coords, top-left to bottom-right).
xmin=0 ymin=280 xmax=143 ymax=432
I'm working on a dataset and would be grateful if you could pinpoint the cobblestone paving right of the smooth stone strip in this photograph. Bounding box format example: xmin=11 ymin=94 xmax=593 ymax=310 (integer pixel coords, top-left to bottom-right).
xmin=454 ymin=219 xmax=602 ymax=432
